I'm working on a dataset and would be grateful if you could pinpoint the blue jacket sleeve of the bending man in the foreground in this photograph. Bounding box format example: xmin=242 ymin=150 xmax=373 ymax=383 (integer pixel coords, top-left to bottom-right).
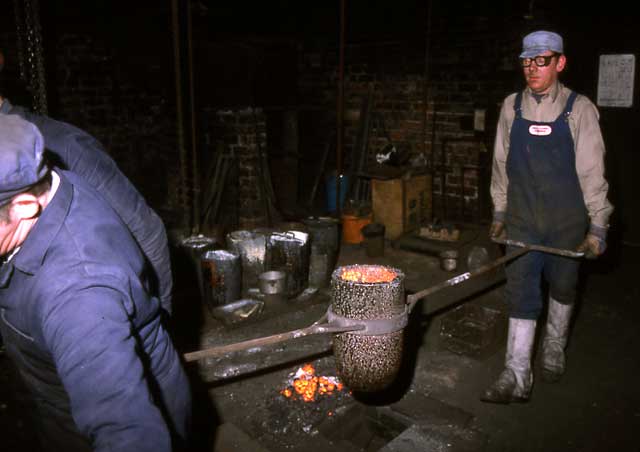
xmin=43 ymin=284 xmax=171 ymax=452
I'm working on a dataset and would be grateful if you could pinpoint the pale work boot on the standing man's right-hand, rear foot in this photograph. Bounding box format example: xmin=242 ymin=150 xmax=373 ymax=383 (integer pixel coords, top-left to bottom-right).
xmin=542 ymin=297 xmax=573 ymax=382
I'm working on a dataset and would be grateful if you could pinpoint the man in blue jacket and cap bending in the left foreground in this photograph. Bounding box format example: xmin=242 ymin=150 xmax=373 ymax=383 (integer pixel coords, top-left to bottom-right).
xmin=0 ymin=115 xmax=191 ymax=451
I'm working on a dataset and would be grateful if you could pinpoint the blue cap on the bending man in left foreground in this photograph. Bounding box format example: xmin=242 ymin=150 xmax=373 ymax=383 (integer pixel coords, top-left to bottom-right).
xmin=0 ymin=114 xmax=49 ymax=206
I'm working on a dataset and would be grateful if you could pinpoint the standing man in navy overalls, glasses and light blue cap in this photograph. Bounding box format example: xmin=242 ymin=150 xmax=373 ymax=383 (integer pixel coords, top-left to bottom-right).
xmin=482 ymin=31 xmax=613 ymax=403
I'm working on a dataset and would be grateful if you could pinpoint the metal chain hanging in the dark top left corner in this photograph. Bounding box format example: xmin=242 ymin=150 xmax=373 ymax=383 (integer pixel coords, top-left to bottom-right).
xmin=14 ymin=0 xmax=48 ymax=115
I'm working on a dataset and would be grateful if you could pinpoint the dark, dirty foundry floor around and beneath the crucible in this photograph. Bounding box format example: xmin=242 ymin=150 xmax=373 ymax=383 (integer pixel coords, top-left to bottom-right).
xmin=0 ymin=224 xmax=640 ymax=452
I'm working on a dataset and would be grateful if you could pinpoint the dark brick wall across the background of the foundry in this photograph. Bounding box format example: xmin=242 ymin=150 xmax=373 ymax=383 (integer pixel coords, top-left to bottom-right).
xmin=0 ymin=1 xmax=640 ymax=242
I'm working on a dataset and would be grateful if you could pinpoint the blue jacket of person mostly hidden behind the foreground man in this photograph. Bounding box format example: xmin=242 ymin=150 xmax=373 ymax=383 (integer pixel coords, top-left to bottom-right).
xmin=11 ymin=107 xmax=173 ymax=313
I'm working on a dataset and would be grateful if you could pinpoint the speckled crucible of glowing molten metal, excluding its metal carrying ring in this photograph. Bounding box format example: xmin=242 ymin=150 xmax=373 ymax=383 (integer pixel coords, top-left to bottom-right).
xmin=331 ymin=265 xmax=406 ymax=392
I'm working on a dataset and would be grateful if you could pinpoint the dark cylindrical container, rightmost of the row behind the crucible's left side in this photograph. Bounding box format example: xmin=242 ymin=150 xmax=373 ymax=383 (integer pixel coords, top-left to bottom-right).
xmin=304 ymin=217 xmax=340 ymax=287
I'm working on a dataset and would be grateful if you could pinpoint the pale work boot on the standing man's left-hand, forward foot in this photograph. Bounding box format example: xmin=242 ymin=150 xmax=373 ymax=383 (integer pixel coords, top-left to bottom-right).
xmin=481 ymin=318 xmax=536 ymax=403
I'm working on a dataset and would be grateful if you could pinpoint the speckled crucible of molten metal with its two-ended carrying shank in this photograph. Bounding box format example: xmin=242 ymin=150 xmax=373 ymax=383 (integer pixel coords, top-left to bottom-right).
xmin=184 ymin=242 xmax=583 ymax=392
